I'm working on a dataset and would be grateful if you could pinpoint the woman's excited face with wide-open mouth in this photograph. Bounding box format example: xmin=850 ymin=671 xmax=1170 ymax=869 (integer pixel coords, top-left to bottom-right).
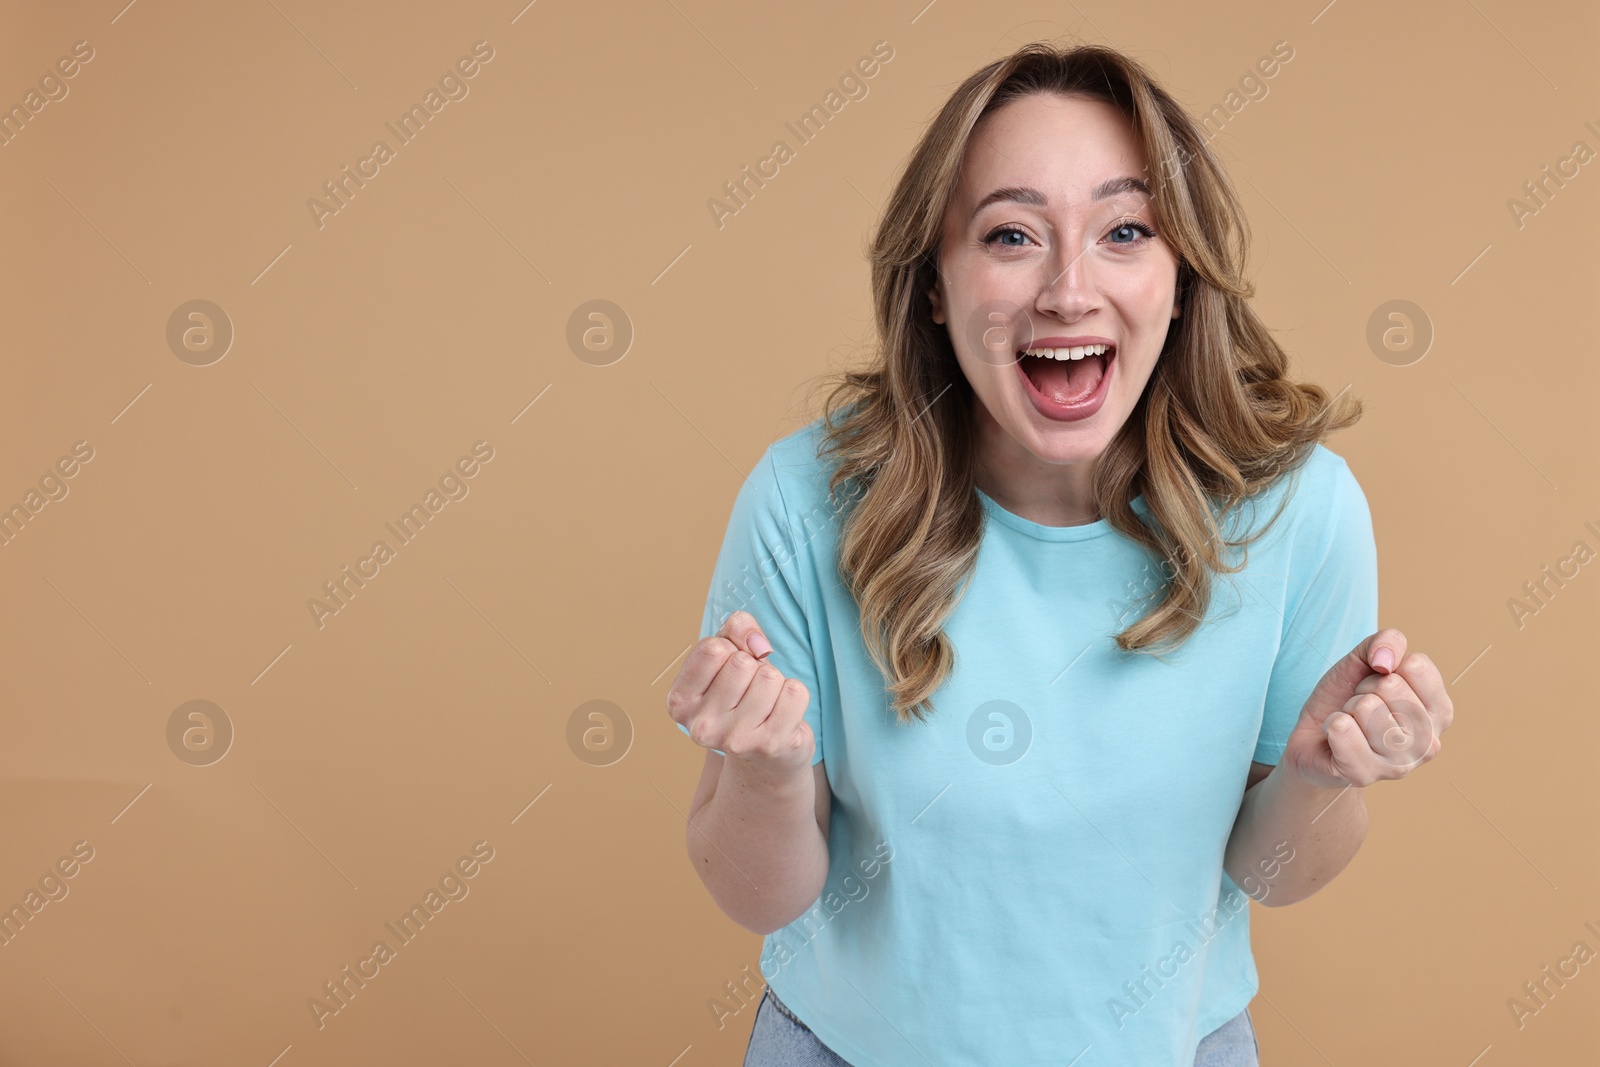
xmin=930 ymin=93 xmax=1178 ymax=467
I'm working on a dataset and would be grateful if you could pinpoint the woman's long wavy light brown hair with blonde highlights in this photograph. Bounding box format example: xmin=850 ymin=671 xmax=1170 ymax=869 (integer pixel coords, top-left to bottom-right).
xmin=800 ymin=42 xmax=1362 ymax=723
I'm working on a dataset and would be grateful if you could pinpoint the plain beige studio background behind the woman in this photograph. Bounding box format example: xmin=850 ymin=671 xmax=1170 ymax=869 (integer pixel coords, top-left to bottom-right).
xmin=0 ymin=0 xmax=1600 ymax=1067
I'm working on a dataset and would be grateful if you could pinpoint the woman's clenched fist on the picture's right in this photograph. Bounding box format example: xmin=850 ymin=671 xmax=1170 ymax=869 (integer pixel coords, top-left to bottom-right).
xmin=1282 ymin=629 xmax=1454 ymax=789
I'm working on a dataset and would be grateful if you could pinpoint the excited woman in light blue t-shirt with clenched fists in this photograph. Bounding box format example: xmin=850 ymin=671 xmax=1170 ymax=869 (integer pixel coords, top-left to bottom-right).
xmin=667 ymin=43 xmax=1453 ymax=1067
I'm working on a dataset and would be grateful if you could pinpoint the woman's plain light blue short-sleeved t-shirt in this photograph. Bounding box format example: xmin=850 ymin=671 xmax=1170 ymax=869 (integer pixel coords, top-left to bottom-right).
xmin=680 ymin=421 xmax=1378 ymax=1067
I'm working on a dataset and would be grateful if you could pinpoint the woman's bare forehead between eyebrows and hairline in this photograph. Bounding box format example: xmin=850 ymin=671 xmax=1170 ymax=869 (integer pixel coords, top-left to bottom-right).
xmin=957 ymin=93 xmax=1146 ymax=205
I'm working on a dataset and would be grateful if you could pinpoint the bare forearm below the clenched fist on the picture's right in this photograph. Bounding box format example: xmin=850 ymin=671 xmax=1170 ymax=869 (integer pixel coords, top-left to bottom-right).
xmin=1222 ymin=765 xmax=1366 ymax=907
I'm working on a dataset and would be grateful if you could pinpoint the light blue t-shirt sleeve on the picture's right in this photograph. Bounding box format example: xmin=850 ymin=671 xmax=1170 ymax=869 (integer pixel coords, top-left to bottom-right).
xmin=1251 ymin=453 xmax=1378 ymax=763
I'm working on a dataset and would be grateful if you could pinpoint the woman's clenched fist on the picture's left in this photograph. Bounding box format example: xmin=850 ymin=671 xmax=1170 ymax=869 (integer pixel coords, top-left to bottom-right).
xmin=667 ymin=611 xmax=816 ymax=781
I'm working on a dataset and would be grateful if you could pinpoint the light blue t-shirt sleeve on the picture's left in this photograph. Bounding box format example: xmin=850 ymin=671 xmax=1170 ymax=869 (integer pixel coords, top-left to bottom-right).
xmin=677 ymin=448 xmax=822 ymax=766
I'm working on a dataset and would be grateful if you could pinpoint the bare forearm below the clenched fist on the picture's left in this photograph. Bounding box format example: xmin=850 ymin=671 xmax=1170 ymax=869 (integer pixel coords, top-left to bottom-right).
xmin=686 ymin=758 xmax=829 ymax=934
